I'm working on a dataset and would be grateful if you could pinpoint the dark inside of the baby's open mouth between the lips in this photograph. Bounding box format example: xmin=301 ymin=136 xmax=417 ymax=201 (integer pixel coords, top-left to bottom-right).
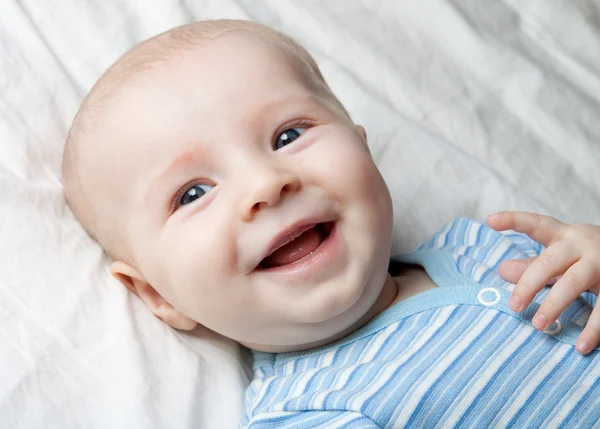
xmin=258 ymin=222 xmax=334 ymax=269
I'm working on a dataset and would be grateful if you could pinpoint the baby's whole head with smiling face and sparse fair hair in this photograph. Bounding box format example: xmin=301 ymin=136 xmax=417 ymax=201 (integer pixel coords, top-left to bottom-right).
xmin=63 ymin=20 xmax=392 ymax=351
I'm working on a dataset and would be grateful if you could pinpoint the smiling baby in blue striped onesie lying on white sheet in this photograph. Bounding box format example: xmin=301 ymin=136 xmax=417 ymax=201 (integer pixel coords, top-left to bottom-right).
xmin=63 ymin=20 xmax=600 ymax=428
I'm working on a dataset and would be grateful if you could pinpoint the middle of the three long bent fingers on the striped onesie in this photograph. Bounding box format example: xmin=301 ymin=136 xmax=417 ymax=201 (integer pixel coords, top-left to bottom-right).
xmin=533 ymin=260 xmax=596 ymax=331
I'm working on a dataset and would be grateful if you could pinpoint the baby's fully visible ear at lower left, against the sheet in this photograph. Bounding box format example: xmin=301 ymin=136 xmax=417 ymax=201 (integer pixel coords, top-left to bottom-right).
xmin=110 ymin=261 xmax=198 ymax=331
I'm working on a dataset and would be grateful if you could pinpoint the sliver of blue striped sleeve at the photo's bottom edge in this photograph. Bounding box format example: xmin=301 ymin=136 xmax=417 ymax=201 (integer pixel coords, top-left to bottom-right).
xmin=244 ymin=410 xmax=381 ymax=429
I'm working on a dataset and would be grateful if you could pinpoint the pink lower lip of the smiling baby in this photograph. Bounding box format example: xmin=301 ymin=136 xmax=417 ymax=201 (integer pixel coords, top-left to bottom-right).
xmin=256 ymin=223 xmax=340 ymax=279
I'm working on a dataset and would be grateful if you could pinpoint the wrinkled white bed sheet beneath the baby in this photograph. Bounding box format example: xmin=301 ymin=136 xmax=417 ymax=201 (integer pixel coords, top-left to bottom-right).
xmin=0 ymin=0 xmax=600 ymax=429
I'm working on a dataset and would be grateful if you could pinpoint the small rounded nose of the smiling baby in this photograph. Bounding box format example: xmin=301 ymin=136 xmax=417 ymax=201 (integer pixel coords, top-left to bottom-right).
xmin=242 ymin=168 xmax=301 ymax=221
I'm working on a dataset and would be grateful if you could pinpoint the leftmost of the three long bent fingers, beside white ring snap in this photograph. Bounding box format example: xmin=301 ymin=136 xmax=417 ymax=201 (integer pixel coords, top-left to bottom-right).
xmin=508 ymin=241 xmax=580 ymax=311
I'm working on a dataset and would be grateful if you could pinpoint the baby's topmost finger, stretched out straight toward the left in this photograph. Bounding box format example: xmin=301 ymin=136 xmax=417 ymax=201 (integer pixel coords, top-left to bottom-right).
xmin=487 ymin=211 xmax=568 ymax=246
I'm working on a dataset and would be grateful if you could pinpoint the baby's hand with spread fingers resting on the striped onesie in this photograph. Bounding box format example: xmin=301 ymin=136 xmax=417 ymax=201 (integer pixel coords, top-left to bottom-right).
xmin=487 ymin=211 xmax=600 ymax=354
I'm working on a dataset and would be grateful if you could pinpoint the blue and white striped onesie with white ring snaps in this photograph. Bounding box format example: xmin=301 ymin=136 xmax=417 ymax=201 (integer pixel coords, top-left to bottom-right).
xmin=241 ymin=218 xmax=600 ymax=428
